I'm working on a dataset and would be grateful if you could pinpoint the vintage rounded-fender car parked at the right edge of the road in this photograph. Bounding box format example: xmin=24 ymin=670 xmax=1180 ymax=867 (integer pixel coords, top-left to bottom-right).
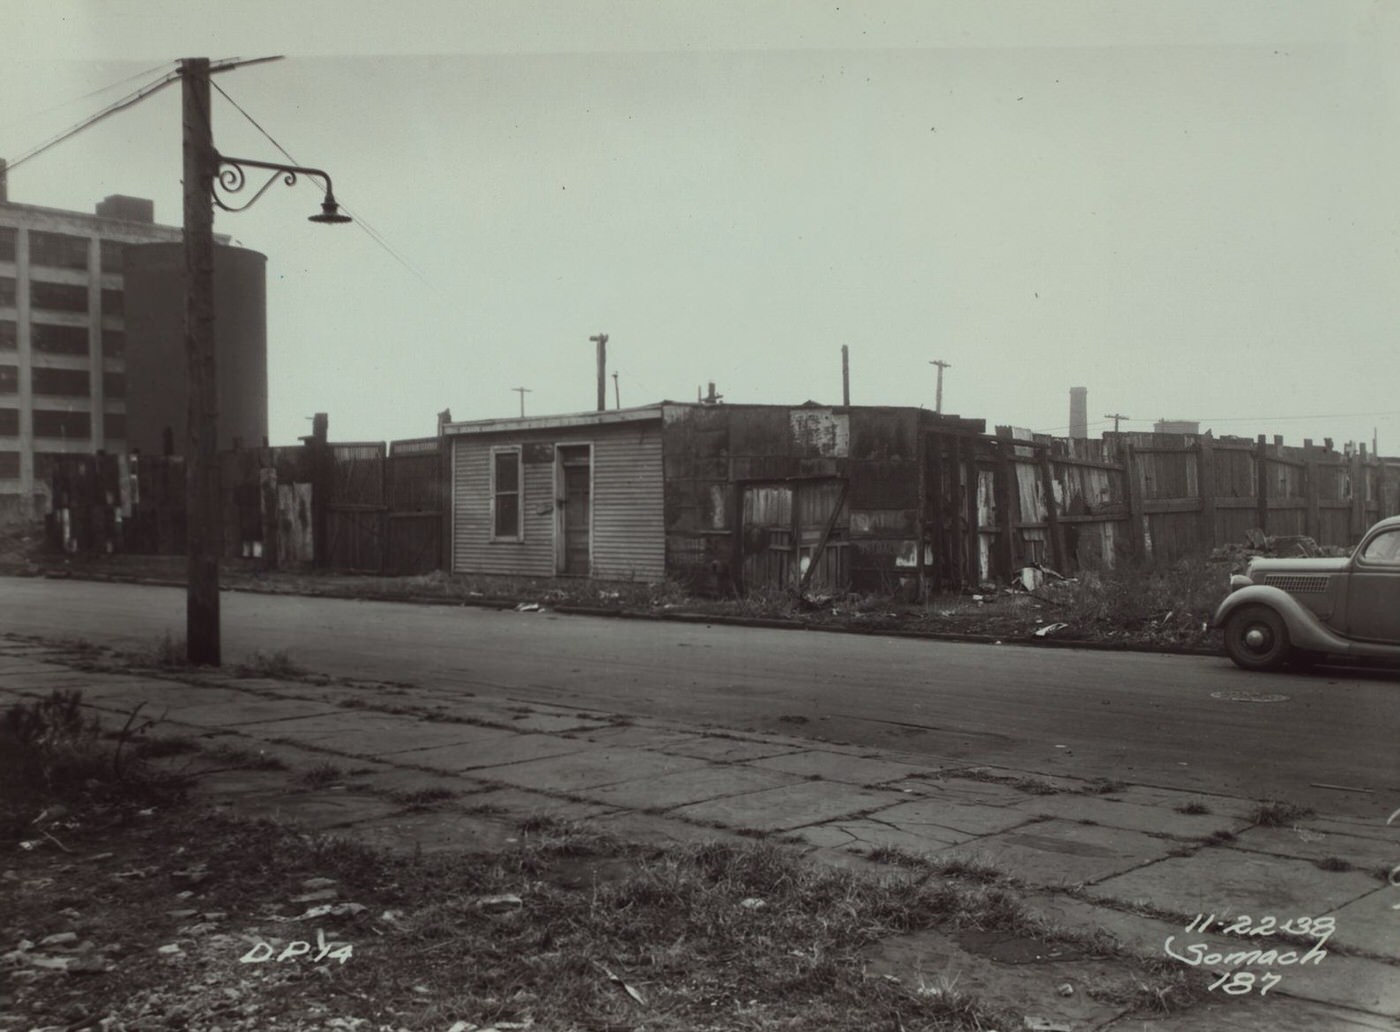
xmin=1212 ymin=517 xmax=1400 ymax=671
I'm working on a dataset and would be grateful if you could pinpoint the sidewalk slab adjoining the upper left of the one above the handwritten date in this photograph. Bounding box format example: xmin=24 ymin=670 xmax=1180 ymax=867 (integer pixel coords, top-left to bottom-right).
xmin=938 ymin=821 xmax=1172 ymax=885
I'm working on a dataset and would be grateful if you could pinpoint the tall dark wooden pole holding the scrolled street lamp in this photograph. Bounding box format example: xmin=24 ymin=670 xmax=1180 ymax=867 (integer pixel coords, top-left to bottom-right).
xmin=181 ymin=57 xmax=224 ymax=667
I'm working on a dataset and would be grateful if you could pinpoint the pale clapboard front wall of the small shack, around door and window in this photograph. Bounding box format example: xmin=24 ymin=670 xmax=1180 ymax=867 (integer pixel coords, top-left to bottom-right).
xmin=452 ymin=421 xmax=665 ymax=581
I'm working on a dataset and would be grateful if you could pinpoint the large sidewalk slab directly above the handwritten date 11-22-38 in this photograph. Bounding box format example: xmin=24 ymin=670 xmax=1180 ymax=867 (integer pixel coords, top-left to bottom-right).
xmin=1088 ymin=849 xmax=1378 ymax=921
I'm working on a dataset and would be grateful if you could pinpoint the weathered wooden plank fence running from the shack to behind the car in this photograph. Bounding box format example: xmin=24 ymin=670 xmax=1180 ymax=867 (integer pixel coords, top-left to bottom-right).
xmin=977 ymin=427 xmax=1400 ymax=580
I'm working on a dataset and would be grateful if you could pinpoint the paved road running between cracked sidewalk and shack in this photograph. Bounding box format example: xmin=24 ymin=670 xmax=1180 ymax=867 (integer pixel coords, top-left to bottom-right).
xmin=0 ymin=578 xmax=1400 ymax=816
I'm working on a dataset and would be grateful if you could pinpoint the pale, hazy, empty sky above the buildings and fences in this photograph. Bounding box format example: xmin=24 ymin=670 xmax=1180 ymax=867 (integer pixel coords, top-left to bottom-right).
xmin=0 ymin=0 xmax=1400 ymax=455
